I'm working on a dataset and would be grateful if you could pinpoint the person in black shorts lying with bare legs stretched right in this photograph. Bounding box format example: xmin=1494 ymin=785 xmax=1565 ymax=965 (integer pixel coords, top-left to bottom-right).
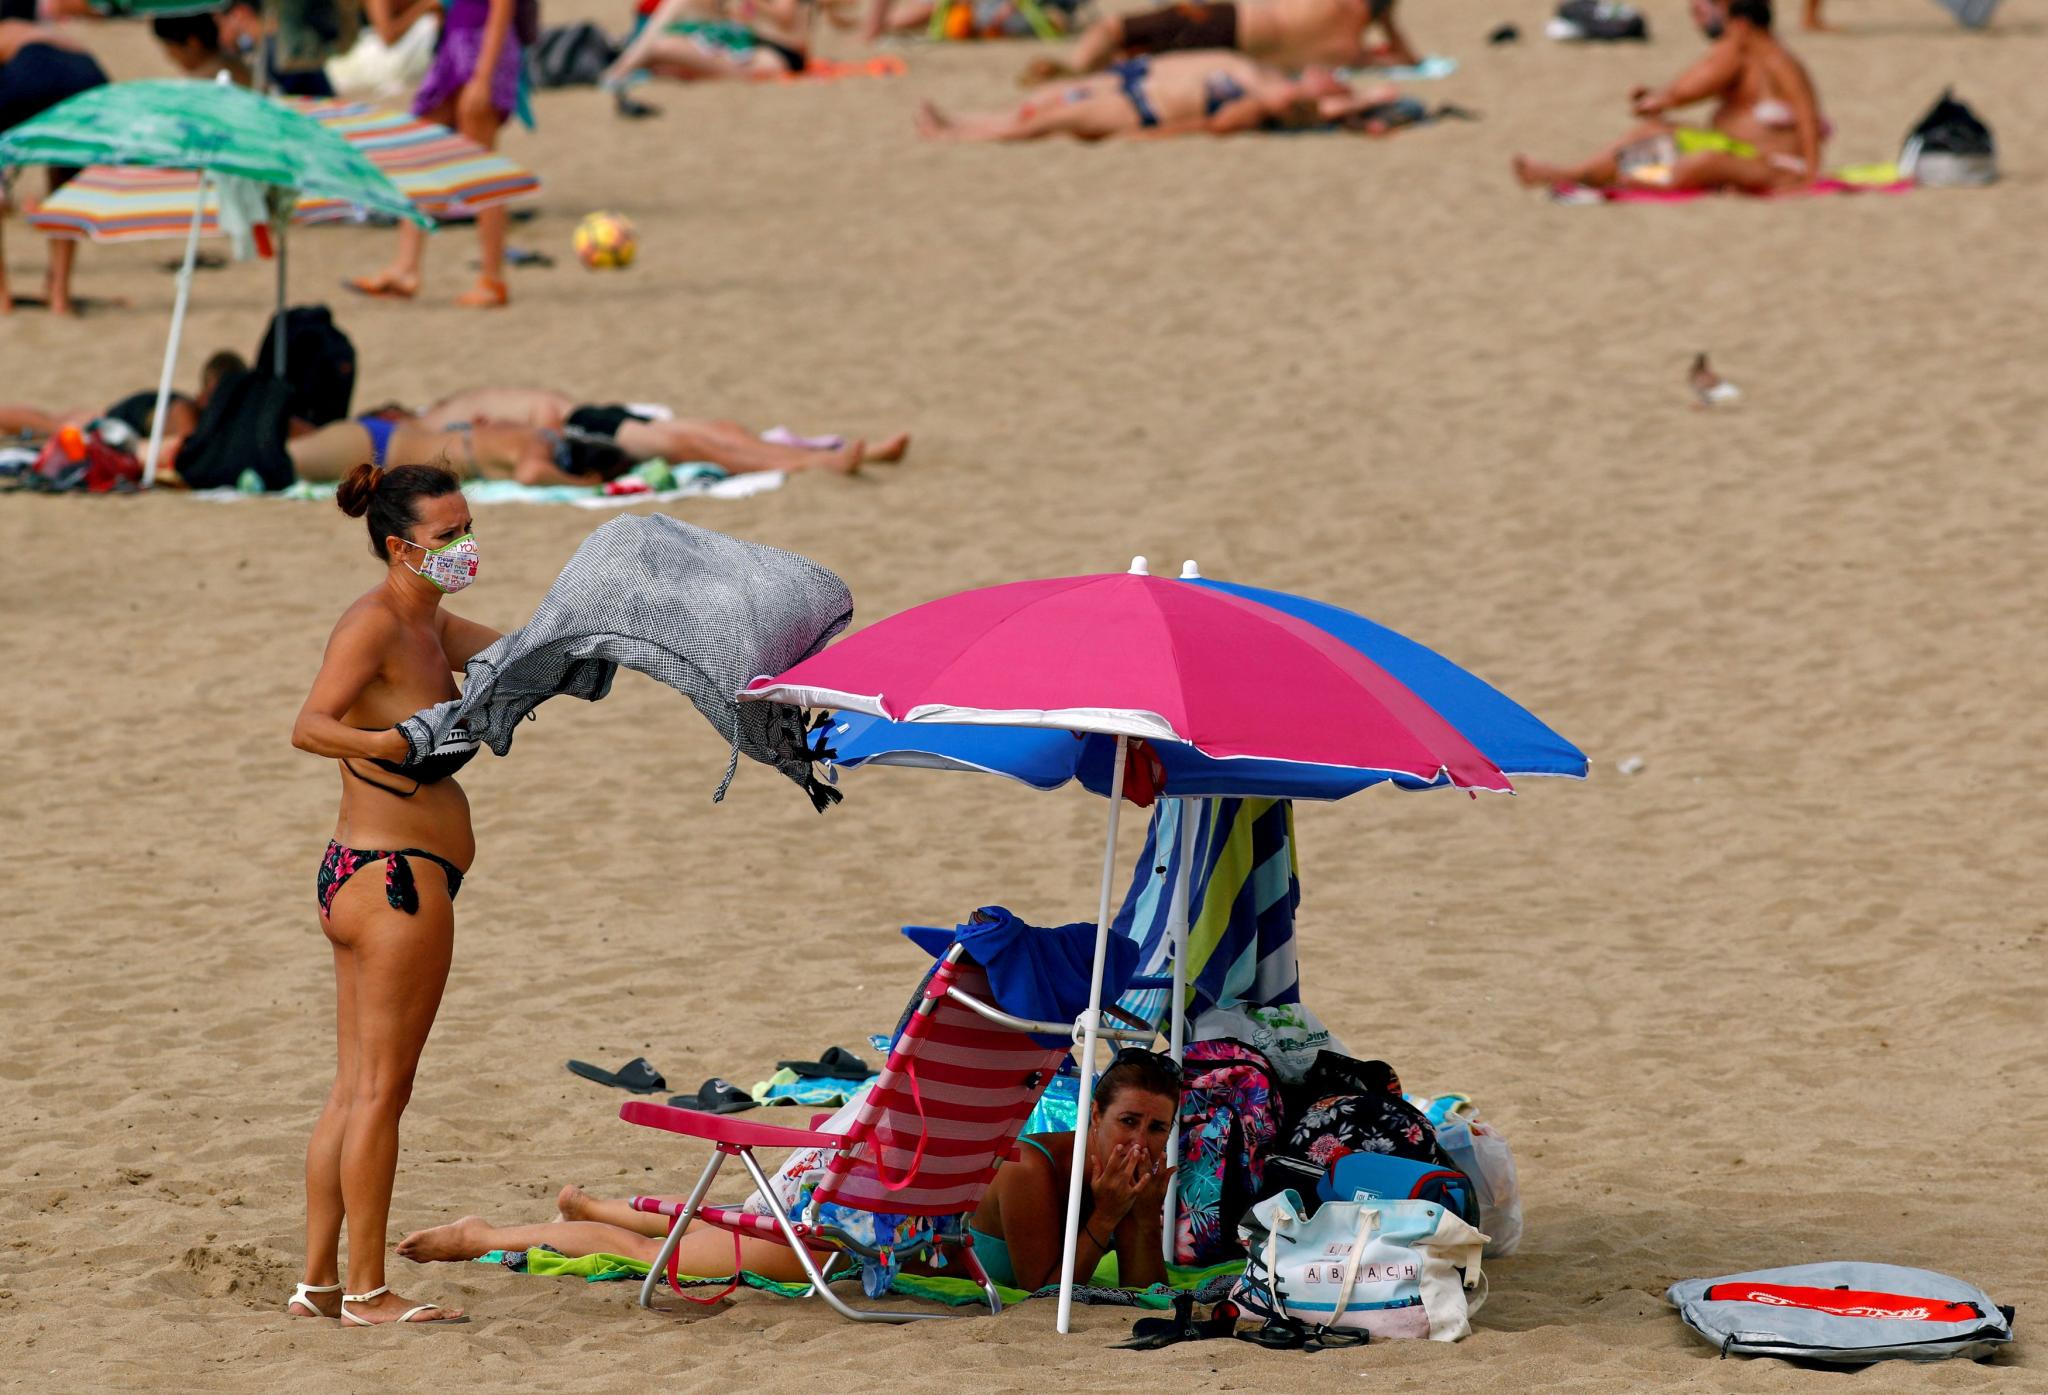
xmin=420 ymin=387 xmax=909 ymax=475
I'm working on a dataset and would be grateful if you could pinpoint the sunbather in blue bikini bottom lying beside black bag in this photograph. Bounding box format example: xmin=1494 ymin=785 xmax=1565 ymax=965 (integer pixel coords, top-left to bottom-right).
xmin=285 ymin=416 xmax=633 ymax=483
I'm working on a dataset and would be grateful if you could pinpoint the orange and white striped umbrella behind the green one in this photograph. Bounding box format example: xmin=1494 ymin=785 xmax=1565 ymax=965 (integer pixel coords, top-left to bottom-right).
xmin=29 ymin=98 xmax=541 ymax=242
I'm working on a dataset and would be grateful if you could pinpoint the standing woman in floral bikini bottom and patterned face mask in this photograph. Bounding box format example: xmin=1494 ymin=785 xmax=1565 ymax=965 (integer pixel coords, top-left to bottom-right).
xmin=287 ymin=465 xmax=498 ymax=1325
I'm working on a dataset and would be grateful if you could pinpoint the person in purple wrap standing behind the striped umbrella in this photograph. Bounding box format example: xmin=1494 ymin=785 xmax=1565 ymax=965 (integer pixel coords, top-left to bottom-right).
xmin=344 ymin=0 xmax=524 ymax=309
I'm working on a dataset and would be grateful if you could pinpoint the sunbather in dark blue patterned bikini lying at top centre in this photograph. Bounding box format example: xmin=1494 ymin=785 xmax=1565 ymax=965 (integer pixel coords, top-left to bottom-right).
xmin=918 ymin=49 xmax=1401 ymax=141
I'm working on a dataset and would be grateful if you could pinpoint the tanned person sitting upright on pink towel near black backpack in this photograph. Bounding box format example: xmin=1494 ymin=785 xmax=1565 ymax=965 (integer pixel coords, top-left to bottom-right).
xmin=1513 ymin=0 xmax=1827 ymax=193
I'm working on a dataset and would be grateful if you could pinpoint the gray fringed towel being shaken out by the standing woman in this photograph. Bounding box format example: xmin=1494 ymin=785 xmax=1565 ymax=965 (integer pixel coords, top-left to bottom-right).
xmin=403 ymin=514 xmax=854 ymax=809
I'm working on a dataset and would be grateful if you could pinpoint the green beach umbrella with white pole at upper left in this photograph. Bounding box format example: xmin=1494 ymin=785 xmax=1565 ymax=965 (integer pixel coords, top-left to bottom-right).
xmin=0 ymin=76 xmax=434 ymax=483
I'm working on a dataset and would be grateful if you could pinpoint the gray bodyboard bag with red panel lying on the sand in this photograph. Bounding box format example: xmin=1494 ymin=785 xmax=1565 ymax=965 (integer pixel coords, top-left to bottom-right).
xmin=1665 ymin=1260 xmax=2013 ymax=1366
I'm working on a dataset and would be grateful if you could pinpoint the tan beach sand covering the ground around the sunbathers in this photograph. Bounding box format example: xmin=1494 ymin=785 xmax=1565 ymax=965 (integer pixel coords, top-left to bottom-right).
xmin=0 ymin=0 xmax=2048 ymax=1395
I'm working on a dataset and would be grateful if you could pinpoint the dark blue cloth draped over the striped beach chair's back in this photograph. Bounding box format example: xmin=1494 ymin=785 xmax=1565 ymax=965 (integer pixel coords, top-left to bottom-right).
xmin=903 ymin=905 xmax=1139 ymax=1047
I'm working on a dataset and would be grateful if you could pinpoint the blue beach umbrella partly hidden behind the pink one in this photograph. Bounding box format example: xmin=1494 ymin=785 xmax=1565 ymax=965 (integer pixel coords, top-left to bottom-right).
xmin=802 ymin=578 xmax=1587 ymax=799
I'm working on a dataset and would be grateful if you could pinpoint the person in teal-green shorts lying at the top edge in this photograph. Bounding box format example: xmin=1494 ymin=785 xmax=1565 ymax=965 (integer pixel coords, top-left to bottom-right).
xmin=600 ymin=0 xmax=811 ymax=92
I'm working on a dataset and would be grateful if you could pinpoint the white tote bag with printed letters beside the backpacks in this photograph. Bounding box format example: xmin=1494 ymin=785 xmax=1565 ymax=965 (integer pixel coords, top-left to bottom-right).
xmin=1231 ymin=1190 xmax=1487 ymax=1342
